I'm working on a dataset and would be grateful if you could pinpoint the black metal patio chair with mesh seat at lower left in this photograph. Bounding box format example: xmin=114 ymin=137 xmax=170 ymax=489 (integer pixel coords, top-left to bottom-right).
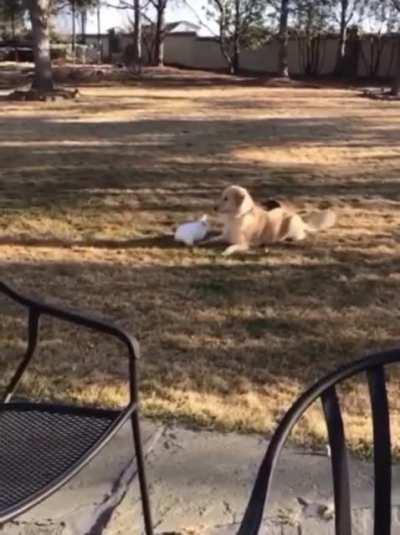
xmin=0 ymin=281 xmax=153 ymax=535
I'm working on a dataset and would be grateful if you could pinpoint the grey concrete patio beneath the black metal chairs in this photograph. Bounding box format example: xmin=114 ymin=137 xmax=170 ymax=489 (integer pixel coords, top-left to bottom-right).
xmin=5 ymin=422 xmax=400 ymax=535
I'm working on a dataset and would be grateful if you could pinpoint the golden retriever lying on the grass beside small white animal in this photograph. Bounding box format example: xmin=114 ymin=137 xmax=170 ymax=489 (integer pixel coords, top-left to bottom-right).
xmin=209 ymin=186 xmax=336 ymax=256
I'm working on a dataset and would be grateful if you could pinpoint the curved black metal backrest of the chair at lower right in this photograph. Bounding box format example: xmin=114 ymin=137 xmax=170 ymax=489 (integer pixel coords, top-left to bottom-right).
xmin=238 ymin=349 xmax=400 ymax=535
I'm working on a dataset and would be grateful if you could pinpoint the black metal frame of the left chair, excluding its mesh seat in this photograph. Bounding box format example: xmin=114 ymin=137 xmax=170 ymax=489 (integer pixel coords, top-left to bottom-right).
xmin=0 ymin=281 xmax=153 ymax=535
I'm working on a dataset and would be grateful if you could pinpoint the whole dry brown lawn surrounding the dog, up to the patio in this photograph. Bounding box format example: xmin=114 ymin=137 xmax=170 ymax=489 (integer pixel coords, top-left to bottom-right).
xmin=0 ymin=70 xmax=400 ymax=456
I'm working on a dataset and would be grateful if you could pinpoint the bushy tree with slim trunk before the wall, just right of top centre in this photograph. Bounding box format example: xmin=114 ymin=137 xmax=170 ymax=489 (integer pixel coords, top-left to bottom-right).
xmin=208 ymin=0 xmax=267 ymax=74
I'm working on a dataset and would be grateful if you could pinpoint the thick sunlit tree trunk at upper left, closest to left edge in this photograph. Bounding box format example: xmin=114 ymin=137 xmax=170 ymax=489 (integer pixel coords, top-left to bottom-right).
xmin=28 ymin=0 xmax=54 ymax=92
